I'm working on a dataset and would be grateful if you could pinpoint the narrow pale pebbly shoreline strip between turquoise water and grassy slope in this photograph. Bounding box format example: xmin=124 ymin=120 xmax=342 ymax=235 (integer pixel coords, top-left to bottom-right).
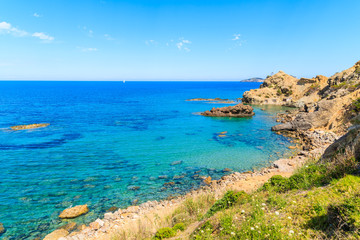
xmin=44 ymin=124 xmax=336 ymax=240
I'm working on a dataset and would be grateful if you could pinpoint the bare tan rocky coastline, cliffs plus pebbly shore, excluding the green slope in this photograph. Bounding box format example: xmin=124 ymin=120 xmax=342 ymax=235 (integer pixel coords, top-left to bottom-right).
xmin=45 ymin=61 xmax=360 ymax=240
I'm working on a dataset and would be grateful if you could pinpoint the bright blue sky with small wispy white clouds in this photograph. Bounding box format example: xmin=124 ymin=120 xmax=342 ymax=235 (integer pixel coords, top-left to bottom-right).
xmin=0 ymin=0 xmax=360 ymax=81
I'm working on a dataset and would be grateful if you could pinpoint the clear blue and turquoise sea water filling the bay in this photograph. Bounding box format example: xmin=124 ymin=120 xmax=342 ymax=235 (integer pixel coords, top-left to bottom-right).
xmin=0 ymin=82 xmax=289 ymax=239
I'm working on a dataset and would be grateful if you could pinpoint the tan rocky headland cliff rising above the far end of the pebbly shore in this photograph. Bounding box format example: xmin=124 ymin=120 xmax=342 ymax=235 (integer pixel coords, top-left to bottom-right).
xmin=243 ymin=61 xmax=360 ymax=132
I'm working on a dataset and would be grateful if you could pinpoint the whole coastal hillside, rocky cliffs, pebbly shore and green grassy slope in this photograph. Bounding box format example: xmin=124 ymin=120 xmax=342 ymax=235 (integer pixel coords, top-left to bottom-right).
xmin=45 ymin=62 xmax=360 ymax=240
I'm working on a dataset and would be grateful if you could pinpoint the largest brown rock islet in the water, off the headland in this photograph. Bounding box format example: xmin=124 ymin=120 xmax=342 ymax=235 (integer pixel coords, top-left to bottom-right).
xmin=201 ymin=103 xmax=255 ymax=117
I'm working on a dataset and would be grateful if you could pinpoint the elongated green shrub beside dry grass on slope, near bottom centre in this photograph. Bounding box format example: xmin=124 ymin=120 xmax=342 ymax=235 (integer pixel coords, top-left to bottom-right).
xmin=205 ymin=191 xmax=248 ymax=218
